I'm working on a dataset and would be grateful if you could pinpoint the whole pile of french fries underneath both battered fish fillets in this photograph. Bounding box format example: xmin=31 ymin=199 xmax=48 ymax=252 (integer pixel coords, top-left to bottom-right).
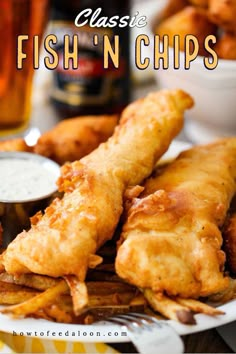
xmin=0 ymin=241 xmax=236 ymax=324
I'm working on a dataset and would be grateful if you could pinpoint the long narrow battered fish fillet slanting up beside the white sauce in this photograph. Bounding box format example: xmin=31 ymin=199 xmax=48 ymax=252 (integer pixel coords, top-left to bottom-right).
xmin=3 ymin=90 xmax=193 ymax=281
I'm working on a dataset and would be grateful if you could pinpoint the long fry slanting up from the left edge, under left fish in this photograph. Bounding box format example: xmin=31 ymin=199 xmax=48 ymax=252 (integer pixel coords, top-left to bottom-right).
xmin=1 ymin=280 xmax=68 ymax=317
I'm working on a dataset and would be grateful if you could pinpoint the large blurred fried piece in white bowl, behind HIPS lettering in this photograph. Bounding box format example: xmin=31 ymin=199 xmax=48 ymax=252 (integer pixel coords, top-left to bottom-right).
xmin=154 ymin=6 xmax=216 ymax=55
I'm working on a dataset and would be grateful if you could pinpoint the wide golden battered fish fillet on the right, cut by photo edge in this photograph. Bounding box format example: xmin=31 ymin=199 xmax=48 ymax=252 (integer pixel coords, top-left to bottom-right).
xmin=116 ymin=138 xmax=236 ymax=298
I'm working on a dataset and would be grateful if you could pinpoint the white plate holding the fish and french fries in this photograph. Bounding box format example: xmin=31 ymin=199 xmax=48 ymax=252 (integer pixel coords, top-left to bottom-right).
xmin=0 ymin=141 xmax=236 ymax=343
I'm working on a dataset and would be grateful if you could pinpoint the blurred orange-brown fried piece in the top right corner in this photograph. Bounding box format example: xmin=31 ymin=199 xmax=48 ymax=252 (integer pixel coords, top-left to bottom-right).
xmin=208 ymin=0 xmax=236 ymax=34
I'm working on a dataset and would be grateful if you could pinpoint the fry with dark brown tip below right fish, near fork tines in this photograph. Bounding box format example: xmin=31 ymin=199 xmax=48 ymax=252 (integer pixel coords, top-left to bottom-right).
xmin=144 ymin=289 xmax=196 ymax=324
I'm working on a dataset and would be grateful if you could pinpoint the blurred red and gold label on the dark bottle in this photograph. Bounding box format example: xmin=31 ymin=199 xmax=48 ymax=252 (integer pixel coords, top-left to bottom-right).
xmin=52 ymin=21 xmax=128 ymax=107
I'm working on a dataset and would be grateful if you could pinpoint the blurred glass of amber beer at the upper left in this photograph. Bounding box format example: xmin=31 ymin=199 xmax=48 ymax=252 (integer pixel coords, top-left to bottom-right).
xmin=0 ymin=0 xmax=49 ymax=139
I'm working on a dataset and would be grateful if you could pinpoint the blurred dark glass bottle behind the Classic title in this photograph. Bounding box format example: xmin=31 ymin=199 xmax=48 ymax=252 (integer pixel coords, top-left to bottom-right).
xmin=52 ymin=0 xmax=130 ymax=118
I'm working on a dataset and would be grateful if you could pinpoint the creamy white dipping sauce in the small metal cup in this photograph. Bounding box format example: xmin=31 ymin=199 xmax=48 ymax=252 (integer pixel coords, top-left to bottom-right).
xmin=0 ymin=158 xmax=58 ymax=202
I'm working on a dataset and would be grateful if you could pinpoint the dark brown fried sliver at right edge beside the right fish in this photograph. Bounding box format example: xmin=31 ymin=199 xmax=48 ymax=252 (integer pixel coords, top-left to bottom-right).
xmin=223 ymin=212 xmax=236 ymax=275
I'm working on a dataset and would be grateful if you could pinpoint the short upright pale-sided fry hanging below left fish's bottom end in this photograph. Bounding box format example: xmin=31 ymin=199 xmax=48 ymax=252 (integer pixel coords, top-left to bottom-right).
xmin=64 ymin=275 xmax=88 ymax=316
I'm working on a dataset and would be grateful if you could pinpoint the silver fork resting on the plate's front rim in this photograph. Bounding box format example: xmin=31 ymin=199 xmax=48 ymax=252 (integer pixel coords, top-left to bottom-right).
xmin=106 ymin=313 xmax=184 ymax=354
